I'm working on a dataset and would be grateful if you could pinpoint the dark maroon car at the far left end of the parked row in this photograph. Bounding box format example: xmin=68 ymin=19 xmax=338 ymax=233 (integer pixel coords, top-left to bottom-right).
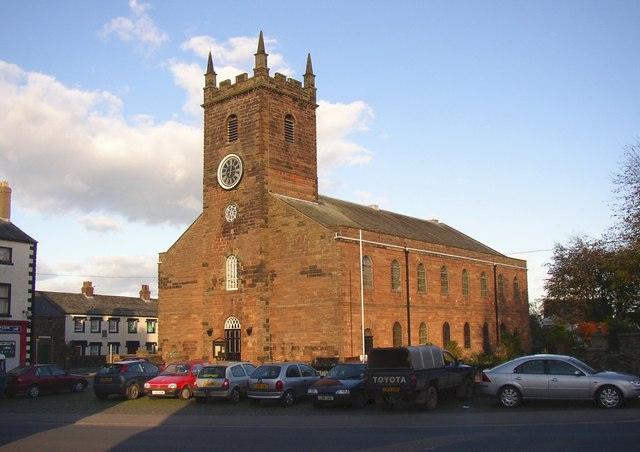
xmin=5 ymin=364 xmax=87 ymax=398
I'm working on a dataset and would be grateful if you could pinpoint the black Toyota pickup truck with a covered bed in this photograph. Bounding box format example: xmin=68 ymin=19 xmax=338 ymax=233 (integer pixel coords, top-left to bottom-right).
xmin=367 ymin=345 xmax=474 ymax=410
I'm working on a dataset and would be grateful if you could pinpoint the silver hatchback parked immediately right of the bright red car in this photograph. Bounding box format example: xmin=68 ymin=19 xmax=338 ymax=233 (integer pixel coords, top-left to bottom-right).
xmin=193 ymin=362 xmax=256 ymax=403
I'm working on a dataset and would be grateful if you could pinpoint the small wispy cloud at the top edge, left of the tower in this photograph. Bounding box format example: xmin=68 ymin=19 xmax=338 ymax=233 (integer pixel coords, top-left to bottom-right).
xmin=100 ymin=0 xmax=169 ymax=50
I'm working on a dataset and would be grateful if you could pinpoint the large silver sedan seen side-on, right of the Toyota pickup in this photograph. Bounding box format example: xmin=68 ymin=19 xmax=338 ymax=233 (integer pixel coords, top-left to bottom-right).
xmin=479 ymin=355 xmax=640 ymax=408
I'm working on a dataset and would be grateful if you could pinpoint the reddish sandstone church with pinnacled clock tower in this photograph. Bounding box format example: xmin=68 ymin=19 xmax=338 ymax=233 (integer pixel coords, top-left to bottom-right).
xmin=158 ymin=33 xmax=530 ymax=363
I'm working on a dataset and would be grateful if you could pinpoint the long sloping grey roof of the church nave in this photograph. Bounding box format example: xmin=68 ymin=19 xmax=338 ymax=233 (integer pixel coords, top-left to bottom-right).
xmin=276 ymin=195 xmax=504 ymax=256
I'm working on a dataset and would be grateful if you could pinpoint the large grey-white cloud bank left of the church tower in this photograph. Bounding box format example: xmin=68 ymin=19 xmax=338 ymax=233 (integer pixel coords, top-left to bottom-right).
xmin=0 ymin=61 xmax=202 ymax=224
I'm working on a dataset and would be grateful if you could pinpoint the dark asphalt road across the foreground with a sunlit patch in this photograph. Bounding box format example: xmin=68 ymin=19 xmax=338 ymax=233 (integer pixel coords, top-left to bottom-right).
xmin=0 ymin=391 xmax=640 ymax=452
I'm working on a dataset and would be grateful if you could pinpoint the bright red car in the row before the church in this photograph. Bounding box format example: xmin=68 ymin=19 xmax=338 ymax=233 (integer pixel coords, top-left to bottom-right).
xmin=144 ymin=362 xmax=204 ymax=400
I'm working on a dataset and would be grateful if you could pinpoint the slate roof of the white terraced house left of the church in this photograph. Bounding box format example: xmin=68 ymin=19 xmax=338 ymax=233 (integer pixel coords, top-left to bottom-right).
xmin=34 ymin=290 xmax=158 ymax=317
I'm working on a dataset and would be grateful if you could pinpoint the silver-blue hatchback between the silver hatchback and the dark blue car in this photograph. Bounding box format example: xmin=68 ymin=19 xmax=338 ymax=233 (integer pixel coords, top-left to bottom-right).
xmin=247 ymin=363 xmax=320 ymax=406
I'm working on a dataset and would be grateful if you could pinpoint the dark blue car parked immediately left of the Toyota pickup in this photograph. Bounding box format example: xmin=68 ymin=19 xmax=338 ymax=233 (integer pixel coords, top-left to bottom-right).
xmin=307 ymin=363 xmax=371 ymax=408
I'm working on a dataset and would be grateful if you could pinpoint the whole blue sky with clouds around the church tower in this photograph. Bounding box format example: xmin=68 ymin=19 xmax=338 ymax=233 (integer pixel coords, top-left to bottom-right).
xmin=0 ymin=0 xmax=640 ymax=304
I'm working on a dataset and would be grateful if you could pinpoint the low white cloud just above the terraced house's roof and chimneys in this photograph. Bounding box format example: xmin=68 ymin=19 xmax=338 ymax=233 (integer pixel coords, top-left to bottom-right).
xmin=37 ymin=255 xmax=158 ymax=298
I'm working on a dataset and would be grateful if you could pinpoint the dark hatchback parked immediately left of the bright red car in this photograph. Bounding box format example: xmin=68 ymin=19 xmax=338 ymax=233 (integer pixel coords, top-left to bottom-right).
xmin=93 ymin=360 xmax=160 ymax=400
